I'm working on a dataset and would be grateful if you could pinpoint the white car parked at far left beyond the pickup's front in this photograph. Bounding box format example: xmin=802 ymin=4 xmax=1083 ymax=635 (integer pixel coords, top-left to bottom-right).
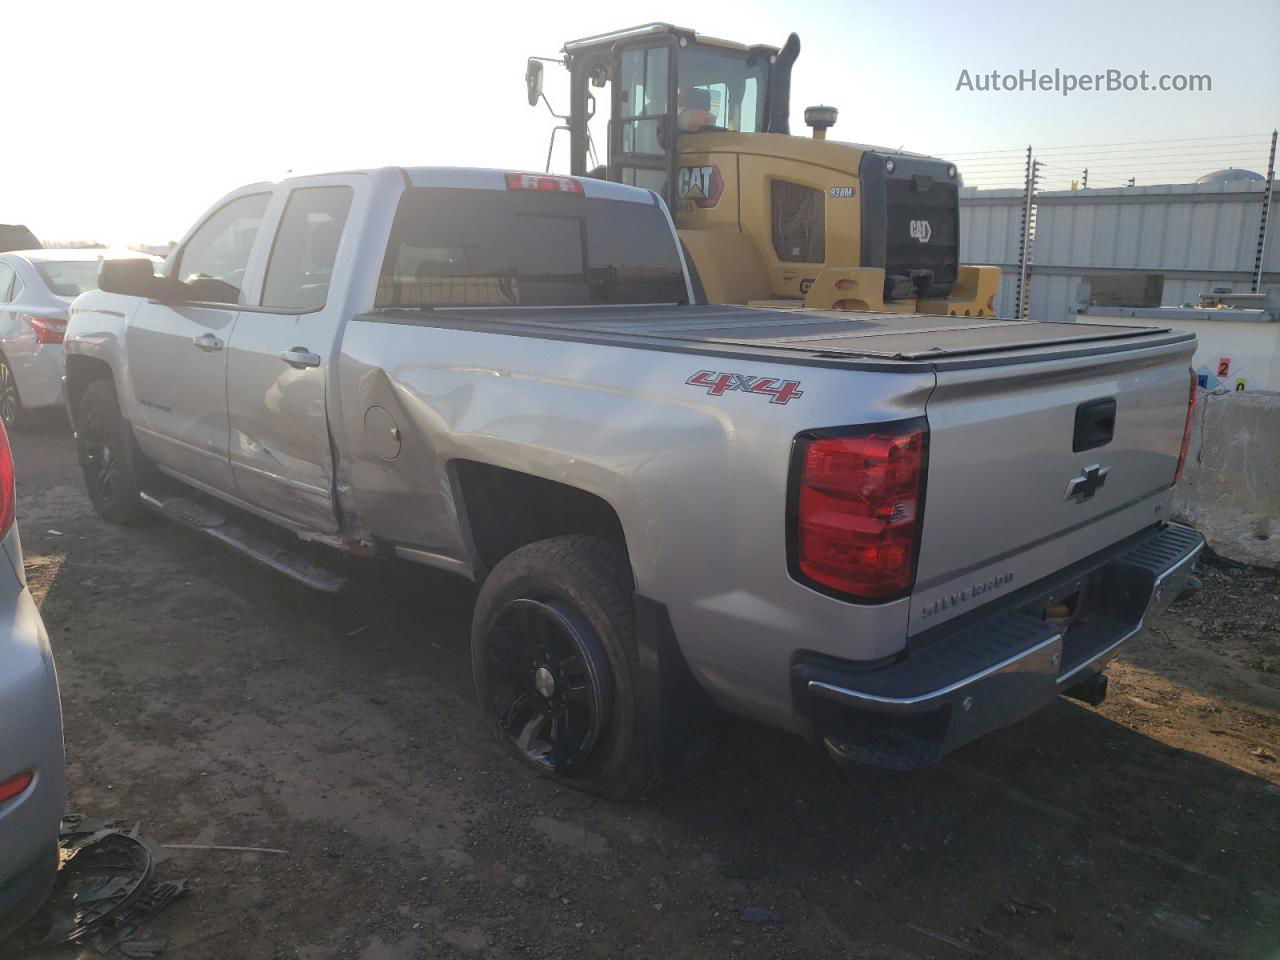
xmin=0 ymin=250 xmax=154 ymax=430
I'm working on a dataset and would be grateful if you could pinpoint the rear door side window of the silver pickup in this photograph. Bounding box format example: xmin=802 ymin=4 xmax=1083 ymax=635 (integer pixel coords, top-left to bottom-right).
xmin=262 ymin=187 xmax=352 ymax=311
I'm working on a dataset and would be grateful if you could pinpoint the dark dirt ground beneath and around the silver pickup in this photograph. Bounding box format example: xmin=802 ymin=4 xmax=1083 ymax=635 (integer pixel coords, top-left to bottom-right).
xmin=5 ymin=422 xmax=1280 ymax=960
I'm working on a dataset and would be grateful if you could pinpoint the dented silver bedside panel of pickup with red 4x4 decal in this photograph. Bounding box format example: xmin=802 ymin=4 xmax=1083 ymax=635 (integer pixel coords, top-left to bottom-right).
xmin=339 ymin=320 xmax=934 ymax=727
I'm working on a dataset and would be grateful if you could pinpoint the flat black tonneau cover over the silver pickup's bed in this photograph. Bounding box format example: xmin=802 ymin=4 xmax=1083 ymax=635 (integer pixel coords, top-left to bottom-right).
xmin=356 ymin=303 xmax=1193 ymax=369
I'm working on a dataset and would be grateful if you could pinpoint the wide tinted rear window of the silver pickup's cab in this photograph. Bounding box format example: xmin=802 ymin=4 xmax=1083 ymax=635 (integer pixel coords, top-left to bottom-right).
xmin=375 ymin=187 xmax=689 ymax=307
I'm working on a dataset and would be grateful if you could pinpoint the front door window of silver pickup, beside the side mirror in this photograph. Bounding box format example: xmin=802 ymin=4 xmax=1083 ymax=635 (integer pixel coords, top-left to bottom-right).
xmin=174 ymin=193 xmax=271 ymax=303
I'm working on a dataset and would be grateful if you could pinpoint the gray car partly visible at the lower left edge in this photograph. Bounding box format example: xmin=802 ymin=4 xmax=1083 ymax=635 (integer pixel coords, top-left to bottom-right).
xmin=0 ymin=419 xmax=67 ymax=940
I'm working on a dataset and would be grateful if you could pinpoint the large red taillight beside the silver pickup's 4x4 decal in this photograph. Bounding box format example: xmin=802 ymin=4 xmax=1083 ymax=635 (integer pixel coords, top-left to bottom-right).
xmin=794 ymin=421 xmax=928 ymax=602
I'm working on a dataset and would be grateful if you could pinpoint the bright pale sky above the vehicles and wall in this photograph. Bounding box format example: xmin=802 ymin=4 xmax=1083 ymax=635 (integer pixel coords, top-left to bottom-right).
xmin=0 ymin=0 xmax=1280 ymax=243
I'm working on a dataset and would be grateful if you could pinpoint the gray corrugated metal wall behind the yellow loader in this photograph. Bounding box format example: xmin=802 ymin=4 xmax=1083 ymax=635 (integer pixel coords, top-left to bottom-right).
xmin=960 ymin=180 xmax=1280 ymax=320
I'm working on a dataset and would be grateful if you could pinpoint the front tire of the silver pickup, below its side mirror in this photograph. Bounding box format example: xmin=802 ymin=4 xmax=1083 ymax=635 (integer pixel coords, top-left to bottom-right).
xmin=76 ymin=380 xmax=147 ymax=525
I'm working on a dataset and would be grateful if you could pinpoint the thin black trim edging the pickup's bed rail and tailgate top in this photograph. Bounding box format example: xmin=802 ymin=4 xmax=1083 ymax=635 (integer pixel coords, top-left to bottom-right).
xmin=351 ymin=308 xmax=1196 ymax=372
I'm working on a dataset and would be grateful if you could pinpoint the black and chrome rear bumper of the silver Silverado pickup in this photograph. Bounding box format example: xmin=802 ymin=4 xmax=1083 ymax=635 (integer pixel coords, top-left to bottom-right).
xmin=792 ymin=524 xmax=1204 ymax=769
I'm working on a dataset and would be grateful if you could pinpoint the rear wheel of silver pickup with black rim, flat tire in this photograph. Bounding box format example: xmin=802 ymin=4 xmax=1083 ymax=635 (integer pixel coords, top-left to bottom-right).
xmin=471 ymin=535 xmax=658 ymax=800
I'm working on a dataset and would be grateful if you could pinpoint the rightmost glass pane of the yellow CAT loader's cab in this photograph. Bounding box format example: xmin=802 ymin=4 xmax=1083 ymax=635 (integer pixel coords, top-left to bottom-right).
xmin=678 ymin=44 xmax=769 ymax=133
